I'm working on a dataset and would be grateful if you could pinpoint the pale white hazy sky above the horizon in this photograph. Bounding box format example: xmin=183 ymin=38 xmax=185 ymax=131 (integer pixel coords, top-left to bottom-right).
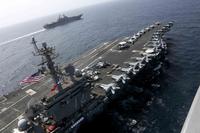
xmin=0 ymin=0 xmax=110 ymax=27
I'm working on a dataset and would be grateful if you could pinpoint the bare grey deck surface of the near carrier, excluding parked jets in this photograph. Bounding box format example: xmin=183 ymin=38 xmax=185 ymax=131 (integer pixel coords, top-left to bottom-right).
xmin=0 ymin=24 xmax=163 ymax=133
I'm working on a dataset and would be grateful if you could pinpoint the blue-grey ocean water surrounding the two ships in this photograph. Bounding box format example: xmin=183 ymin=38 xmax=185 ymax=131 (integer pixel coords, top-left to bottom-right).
xmin=0 ymin=0 xmax=200 ymax=133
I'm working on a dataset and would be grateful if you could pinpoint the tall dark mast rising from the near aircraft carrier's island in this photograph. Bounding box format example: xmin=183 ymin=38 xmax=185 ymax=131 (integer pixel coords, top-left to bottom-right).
xmin=31 ymin=37 xmax=63 ymax=91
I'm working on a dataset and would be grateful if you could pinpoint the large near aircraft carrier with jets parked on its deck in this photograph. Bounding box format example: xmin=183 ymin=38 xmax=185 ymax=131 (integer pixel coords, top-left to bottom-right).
xmin=0 ymin=22 xmax=173 ymax=133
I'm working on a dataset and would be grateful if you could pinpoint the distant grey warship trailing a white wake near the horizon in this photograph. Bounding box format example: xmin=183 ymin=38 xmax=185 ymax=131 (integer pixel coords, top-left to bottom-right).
xmin=43 ymin=14 xmax=83 ymax=29
